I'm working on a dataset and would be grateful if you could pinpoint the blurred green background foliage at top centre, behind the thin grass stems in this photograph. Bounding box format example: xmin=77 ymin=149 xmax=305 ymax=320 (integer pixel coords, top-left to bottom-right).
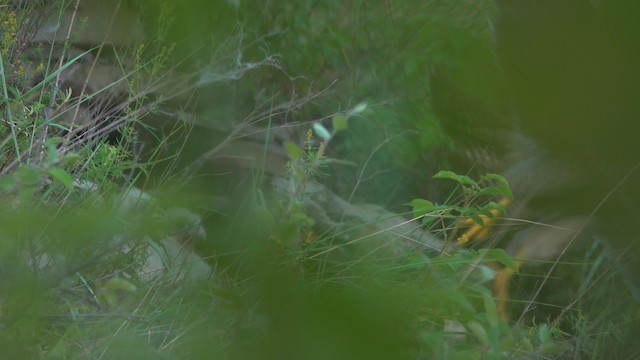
xmin=154 ymin=1 xmax=497 ymax=209
